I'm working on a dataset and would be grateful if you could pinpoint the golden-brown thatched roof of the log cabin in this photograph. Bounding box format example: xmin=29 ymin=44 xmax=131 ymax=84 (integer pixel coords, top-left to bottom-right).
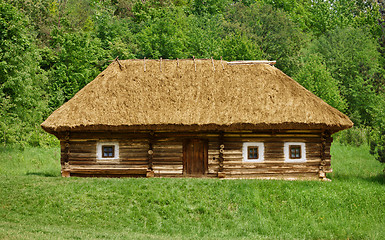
xmin=41 ymin=59 xmax=353 ymax=133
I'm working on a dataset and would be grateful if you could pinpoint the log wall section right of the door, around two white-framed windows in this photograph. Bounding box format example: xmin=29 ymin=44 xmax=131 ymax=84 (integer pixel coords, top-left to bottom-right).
xmin=209 ymin=131 xmax=332 ymax=179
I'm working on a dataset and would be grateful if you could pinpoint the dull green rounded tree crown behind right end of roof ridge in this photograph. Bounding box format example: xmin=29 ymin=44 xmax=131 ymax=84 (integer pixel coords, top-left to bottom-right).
xmin=225 ymin=4 xmax=304 ymax=74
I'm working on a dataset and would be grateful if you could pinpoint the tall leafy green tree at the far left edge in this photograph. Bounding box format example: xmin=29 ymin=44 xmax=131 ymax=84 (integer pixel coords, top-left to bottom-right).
xmin=0 ymin=2 xmax=47 ymax=145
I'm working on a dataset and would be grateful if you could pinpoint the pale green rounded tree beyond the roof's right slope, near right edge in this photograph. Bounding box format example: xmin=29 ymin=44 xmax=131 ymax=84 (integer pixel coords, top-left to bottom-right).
xmin=309 ymin=27 xmax=385 ymax=126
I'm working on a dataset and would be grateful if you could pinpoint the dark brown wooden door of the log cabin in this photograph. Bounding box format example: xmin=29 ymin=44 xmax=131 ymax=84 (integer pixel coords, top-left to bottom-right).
xmin=183 ymin=139 xmax=208 ymax=176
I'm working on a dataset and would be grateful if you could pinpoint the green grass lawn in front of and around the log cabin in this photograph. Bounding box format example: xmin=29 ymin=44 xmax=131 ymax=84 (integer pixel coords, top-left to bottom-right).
xmin=0 ymin=144 xmax=385 ymax=239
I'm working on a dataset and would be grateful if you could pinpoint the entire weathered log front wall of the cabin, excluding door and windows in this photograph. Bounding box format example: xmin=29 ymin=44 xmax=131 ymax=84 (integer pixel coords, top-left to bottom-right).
xmin=61 ymin=130 xmax=332 ymax=179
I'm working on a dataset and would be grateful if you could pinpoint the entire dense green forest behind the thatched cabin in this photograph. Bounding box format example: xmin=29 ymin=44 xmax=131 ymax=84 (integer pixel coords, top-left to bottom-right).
xmin=0 ymin=0 xmax=385 ymax=161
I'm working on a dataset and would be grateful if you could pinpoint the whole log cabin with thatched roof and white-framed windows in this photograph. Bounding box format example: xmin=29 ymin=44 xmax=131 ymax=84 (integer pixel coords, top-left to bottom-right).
xmin=41 ymin=59 xmax=353 ymax=180
